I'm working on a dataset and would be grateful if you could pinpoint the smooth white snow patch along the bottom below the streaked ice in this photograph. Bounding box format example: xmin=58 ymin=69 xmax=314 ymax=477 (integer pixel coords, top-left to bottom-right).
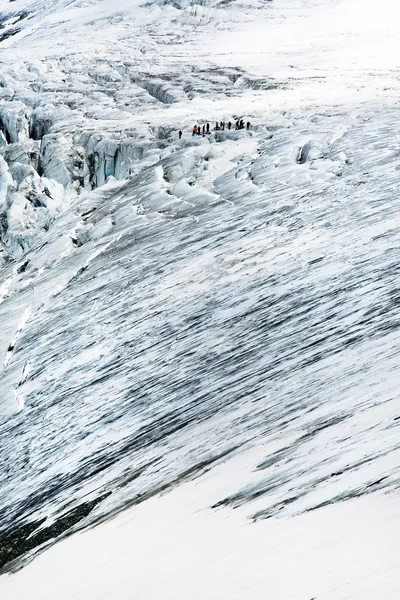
xmin=0 ymin=458 xmax=400 ymax=600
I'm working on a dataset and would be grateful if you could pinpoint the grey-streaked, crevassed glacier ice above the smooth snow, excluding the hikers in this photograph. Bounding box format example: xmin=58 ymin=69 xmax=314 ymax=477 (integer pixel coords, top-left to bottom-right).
xmin=0 ymin=0 xmax=400 ymax=584
